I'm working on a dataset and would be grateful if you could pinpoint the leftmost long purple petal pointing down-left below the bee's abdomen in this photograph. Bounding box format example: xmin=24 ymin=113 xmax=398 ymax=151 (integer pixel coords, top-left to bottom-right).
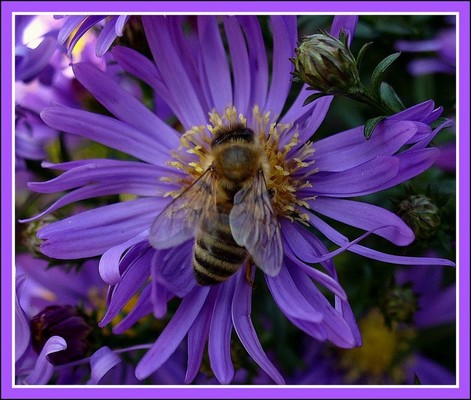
xmin=136 ymin=287 xmax=209 ymax=380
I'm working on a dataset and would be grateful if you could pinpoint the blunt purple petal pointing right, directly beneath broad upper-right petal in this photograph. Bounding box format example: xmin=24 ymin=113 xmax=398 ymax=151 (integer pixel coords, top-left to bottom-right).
xmin=301 ymin=156 xmax=399 ymax=197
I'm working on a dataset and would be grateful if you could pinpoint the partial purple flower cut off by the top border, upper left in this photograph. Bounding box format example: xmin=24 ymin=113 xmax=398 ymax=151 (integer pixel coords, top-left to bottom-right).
xmin=57 ymin=15 xmax=129 ymax=57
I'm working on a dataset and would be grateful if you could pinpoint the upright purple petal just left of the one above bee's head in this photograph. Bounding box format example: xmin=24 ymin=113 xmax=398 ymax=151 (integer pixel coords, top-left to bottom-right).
xmin=197 ymin=15 xmax=233 ymax=112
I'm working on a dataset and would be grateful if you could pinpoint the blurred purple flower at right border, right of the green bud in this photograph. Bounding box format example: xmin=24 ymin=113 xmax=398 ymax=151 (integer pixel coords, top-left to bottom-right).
xmin=396 ymin=21 xmax=456 ymax=76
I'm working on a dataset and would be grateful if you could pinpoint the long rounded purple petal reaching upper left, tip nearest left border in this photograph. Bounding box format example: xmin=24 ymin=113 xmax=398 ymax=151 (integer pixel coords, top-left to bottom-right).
xmin=41 ymin=106 xmax=169 ymax=165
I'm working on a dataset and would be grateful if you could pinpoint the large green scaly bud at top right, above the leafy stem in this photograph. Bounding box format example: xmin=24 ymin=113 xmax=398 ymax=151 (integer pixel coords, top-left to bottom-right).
xmin=291 ymin=32 xmax=361 ymax=94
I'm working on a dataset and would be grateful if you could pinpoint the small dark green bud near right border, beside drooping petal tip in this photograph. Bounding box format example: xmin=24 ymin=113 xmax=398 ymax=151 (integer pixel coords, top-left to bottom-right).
xmin=397 ymin=195 xmax=440 ymax=239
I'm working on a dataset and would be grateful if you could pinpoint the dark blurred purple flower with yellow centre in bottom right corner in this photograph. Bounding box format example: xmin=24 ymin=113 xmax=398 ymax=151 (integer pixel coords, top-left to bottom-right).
xmin=296 ymin=266 xmax=456 ymax=385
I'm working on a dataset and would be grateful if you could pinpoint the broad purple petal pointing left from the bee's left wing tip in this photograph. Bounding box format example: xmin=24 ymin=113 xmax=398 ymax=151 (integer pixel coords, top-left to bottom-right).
xmin=37 ymin=198 xmax=163 ymax=259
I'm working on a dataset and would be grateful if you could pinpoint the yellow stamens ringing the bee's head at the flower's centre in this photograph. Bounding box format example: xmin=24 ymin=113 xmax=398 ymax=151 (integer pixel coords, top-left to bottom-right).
xmin=161 ymin=105 xmax=318 ymax=224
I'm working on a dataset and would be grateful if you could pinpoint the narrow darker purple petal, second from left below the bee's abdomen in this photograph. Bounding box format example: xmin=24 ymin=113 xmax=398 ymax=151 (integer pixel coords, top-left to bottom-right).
xmin=185 ymin=288 xmax=218 ymax=384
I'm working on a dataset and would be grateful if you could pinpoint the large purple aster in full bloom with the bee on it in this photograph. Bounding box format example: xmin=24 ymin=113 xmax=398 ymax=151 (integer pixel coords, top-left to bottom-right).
xmin=30 ymin=16 xmax=453 ymax=383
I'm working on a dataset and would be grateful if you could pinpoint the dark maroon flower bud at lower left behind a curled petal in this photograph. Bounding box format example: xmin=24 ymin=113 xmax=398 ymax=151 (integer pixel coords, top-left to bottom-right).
xmin=30 ymin=305 xmax=92 ymax=365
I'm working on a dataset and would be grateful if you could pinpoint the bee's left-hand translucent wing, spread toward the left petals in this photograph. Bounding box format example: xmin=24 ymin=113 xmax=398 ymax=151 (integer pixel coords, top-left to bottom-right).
xmin=149 ymin=168 xmax=216 ymax=249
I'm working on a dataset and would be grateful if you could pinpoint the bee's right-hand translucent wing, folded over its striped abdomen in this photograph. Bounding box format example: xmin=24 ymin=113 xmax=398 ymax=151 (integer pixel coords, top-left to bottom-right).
xmin=229 ymin=167 xmax=283 ymax=276
